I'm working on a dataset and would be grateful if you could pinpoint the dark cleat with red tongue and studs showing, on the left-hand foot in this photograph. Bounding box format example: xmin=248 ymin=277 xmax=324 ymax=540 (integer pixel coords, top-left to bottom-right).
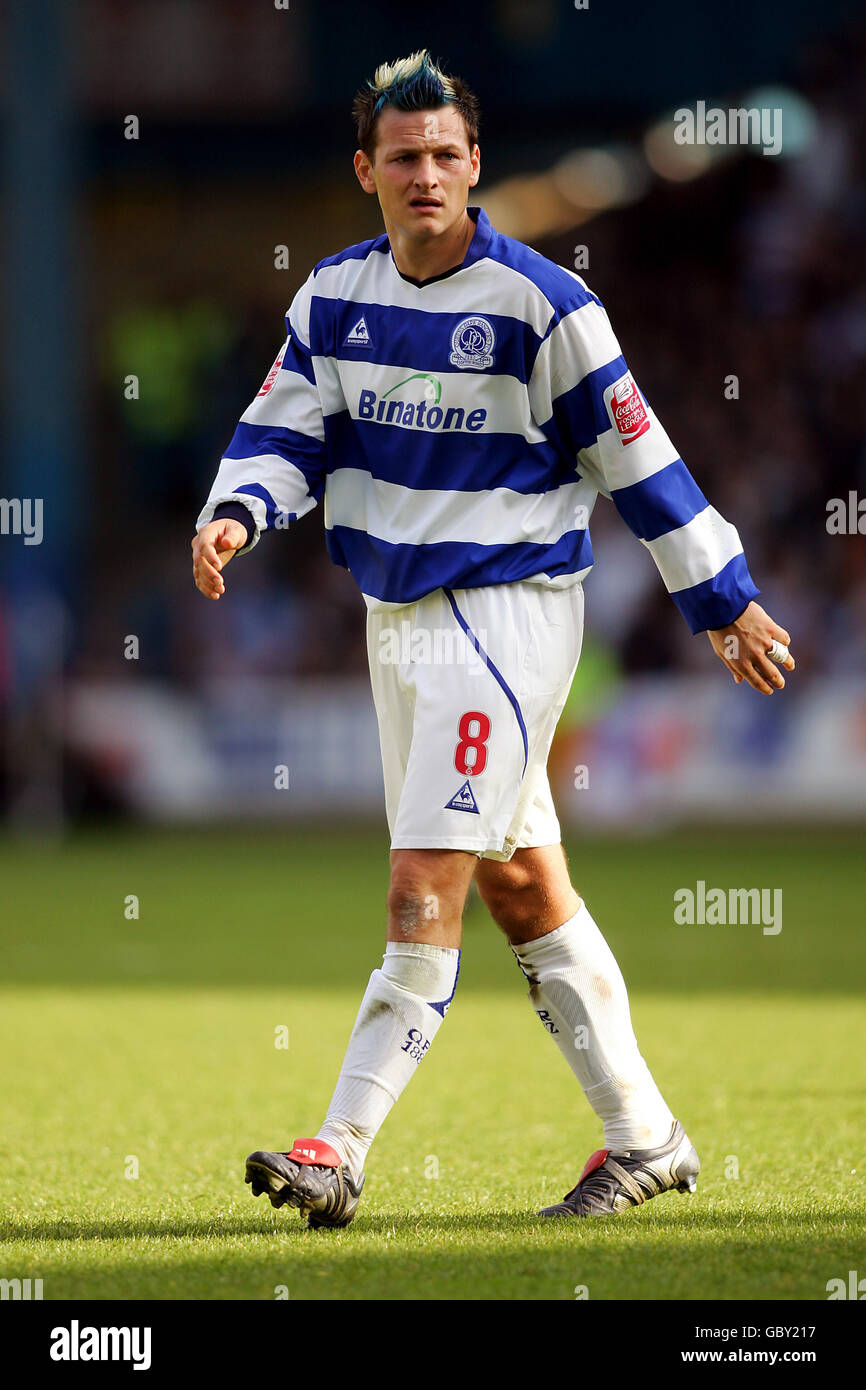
xmin=243 ymin=1138 xmax=366 ymax=1230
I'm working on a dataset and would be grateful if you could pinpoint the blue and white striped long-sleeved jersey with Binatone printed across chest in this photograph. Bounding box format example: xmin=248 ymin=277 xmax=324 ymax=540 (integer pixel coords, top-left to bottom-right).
xmin=197 ymin=209 xmax=758 ymax=632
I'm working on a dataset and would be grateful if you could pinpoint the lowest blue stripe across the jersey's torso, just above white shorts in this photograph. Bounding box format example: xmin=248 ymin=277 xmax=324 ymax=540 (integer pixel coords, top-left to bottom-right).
xmin=325 ymin=525 xmax=592 ymax=603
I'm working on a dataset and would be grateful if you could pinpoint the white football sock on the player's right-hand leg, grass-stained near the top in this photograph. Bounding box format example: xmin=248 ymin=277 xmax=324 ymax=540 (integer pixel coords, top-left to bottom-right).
xmin=512 ymin=902 xmax=674 ymax=1154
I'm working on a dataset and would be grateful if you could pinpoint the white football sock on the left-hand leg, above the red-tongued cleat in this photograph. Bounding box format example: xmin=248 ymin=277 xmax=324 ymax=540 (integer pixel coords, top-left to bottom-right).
xmin=317 ymin=941 xmax=460 ymax=1179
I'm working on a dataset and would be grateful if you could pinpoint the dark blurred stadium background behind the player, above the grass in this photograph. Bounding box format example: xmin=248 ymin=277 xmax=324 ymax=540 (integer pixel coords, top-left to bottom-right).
xmin=0 ymin=0 xmax=866 ymax=827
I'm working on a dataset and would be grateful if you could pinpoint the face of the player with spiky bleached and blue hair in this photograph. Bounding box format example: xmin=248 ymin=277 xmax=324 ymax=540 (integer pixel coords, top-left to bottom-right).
xmin=356 ymin=106 xmax=480 ymax=240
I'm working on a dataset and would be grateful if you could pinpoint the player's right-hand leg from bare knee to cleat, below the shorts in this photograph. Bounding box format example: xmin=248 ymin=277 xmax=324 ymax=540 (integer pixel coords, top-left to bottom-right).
xmin=475 ymin=845 xmax=699 ymax=1215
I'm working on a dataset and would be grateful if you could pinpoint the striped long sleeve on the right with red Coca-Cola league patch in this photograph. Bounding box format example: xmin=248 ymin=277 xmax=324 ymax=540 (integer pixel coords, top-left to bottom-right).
xmin=531 ymin=282 xmax=759 ymax=632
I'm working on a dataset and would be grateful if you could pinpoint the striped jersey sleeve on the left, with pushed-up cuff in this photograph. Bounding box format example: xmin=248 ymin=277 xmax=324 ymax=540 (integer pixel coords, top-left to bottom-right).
xmin=196 ymin=271 xmax=327 ymax=555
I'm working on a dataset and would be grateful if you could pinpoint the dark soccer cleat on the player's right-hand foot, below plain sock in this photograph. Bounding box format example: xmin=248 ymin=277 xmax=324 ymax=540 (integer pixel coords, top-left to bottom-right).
xmin=538 ymin=1120 xmax=701 ymax=1216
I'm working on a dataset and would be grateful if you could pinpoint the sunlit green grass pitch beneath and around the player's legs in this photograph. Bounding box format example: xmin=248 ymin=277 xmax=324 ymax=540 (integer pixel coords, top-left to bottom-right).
xmin=0 ymin=831 xmax=866 ymax=1300
